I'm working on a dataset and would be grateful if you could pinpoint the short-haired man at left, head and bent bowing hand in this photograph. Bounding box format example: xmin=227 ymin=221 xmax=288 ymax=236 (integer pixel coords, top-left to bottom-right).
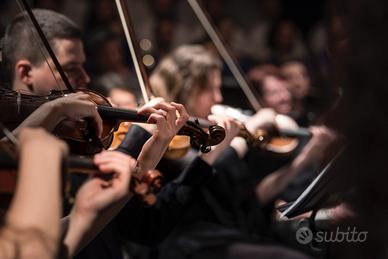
xmin=3 ymin=10 xmax=102 ymax=135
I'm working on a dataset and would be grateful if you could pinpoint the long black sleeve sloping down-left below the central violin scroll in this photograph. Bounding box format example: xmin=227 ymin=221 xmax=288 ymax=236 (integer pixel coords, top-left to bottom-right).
xmin=115 ymin=157 xmax=213 ymax=245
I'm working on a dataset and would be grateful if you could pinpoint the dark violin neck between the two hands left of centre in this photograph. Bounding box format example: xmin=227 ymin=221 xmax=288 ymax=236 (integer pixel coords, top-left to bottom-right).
xmin=98 ymin=105 xmax=148 ymax=123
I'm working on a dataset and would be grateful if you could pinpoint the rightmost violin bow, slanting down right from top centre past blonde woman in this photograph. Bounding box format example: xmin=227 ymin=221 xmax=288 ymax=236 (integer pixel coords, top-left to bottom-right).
xmin=187 ymin=0 xmax=262 ymax=111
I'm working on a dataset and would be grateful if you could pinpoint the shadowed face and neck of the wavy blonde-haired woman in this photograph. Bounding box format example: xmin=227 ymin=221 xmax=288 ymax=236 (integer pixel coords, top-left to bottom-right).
xmin=187 ymin=69 xmax=222 ymax=118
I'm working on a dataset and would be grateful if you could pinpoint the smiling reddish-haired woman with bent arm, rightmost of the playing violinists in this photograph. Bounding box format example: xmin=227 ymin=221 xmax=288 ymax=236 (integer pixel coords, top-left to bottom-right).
xmin=248 ymin=65 xmax=336 ymax=201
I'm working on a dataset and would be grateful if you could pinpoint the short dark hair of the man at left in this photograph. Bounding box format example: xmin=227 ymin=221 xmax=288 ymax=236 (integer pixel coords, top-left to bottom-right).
xmin=3 ymin=9 xmax=82 ymax=82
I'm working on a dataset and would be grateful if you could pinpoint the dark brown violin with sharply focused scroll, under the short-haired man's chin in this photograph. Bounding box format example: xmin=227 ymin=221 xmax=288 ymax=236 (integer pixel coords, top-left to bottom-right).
xmin=0 ymin=89 xmax=225 ymax=155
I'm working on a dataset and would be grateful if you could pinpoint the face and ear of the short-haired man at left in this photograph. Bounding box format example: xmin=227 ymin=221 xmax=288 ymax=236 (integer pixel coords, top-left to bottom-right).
xmin=14 ymin=39 xmax=90 ymax=95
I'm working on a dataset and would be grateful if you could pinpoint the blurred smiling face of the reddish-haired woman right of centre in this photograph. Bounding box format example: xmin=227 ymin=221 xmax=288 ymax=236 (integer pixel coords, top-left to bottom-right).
xmin=262 ymin=76 xmax=292 ymax=114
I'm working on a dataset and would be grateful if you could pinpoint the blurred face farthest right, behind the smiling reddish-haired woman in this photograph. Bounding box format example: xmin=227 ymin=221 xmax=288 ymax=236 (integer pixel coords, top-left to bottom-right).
xmin=281 ymin=62 xmax=311 ymax=100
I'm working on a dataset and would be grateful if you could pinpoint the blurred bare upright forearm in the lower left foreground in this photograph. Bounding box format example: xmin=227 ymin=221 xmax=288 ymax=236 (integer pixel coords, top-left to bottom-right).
xmin=7 ymin=145 xmax=62 ymax=242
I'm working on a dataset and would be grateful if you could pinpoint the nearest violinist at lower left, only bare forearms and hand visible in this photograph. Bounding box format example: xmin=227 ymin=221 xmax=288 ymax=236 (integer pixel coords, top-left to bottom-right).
xmin=0 ymin=129 xmax=135 ymax=258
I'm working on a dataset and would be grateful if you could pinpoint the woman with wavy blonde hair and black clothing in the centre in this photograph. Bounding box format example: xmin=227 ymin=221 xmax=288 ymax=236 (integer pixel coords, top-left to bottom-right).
xmin=150 ymin=45 xmax=316 ymax=258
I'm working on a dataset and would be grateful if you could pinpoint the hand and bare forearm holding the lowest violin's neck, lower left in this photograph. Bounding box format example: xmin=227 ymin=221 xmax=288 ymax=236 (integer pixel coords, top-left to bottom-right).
xmin=64 ymin=151 xmax=136 ymax=258
